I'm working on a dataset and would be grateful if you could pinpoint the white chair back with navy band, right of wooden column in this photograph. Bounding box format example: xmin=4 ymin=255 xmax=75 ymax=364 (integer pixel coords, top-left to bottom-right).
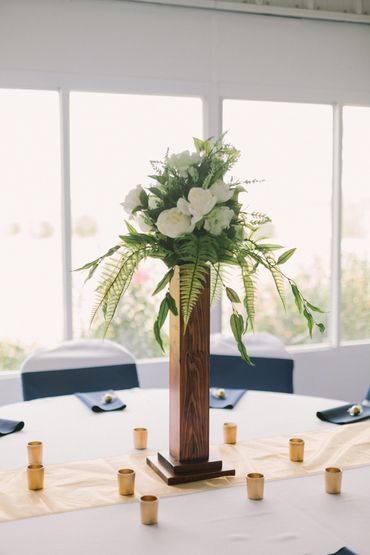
xmin=210 ymin=333 xmax=294 ymax=393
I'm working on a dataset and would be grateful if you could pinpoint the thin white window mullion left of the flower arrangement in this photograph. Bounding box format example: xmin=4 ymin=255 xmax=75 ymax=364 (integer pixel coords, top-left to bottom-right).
xmin=60 ymin=89 xmax=73 ymax=340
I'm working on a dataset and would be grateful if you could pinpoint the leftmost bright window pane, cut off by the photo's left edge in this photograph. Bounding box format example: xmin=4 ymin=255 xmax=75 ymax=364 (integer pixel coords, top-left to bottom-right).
xmin=0 ymin=89 xmax=62 ymax=369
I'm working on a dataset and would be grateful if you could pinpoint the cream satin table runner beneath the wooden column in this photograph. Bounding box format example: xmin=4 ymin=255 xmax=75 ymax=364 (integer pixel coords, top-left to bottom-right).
xmin=0 ymin=421 xmax=370 ymax=522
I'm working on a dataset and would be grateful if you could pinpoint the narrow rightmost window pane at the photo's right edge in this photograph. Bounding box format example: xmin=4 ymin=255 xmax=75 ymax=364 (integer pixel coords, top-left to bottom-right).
xmin=342 ymin=106 xmax=370 ymax=340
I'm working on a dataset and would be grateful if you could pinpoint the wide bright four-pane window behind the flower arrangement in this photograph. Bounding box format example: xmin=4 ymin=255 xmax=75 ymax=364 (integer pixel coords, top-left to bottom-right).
xmin=0 ymin=89 xmax=370 ymax=370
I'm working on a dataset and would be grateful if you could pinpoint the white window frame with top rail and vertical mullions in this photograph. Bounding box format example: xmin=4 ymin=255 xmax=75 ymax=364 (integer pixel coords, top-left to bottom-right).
xmin=0 ymin=77 xmax=370 ymax=360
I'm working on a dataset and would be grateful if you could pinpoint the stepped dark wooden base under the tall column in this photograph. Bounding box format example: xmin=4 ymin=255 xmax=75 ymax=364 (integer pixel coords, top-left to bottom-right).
xmin=146 ymin=453 xmax=235 ymax=486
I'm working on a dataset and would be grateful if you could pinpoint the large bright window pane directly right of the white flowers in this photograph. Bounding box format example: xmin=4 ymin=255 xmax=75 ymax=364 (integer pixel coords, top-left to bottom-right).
xmin=223 ymin=100 xmax=332 ymax=344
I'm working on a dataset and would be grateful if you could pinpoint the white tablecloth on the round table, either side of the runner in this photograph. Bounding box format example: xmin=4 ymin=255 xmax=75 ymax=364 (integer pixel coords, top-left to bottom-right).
xmin=0 ymin=390 xmax=370 ymax=555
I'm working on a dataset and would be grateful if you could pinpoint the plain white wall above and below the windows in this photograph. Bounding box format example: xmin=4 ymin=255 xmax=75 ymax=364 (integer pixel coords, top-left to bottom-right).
xmin=0 ymin=0 xmax=370 ymax=404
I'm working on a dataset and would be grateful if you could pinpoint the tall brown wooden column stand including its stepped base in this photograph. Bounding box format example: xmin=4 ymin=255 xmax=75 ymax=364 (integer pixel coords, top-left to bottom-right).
xmin=147 ymin=267 xmax=235 ymax=485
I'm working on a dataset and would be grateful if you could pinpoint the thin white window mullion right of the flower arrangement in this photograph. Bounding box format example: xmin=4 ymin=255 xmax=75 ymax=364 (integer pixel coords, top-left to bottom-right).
xmin=329 ymin=104 xmax=343 ymax=347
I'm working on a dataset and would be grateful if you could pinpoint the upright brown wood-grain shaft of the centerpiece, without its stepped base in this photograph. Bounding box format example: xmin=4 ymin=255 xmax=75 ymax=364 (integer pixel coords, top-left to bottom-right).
xmin=170 ymin=267 xmax=210 ymax=463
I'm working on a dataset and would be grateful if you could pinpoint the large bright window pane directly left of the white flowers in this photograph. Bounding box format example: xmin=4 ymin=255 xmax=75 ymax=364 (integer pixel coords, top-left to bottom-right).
xmin=71 ymin=93 xmax=202 ymax=357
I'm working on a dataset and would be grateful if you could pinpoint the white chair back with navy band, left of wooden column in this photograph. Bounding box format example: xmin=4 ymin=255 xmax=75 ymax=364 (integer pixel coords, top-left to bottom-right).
xmin=21 ymin=339 xmax=139 ymax=401
